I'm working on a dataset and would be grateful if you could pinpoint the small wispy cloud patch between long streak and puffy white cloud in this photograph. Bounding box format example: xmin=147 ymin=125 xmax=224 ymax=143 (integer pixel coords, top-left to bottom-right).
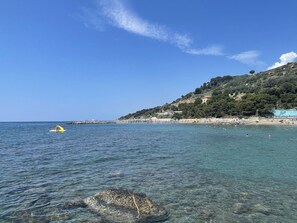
xmin=228 ymin=50 xmax=264 ymax=66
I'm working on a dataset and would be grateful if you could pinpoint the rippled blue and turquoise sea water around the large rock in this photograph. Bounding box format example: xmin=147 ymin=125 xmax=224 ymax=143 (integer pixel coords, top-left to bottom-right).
xmin=0 ymin=123 xmax=297 ymax=223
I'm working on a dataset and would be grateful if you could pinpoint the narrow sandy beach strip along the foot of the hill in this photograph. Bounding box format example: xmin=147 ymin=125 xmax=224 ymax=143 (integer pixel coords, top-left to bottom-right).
xmin=116 ymin=117 xmax=297 ymax=126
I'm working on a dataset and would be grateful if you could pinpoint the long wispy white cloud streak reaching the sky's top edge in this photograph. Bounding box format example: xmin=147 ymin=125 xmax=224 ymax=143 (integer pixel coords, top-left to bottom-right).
xmin=84 ymin=0 xmax=223 ymax=56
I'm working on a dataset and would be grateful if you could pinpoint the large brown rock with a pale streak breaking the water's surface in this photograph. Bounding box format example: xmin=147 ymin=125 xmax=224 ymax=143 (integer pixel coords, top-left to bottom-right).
xmin=83 ymin=189 xmax=169 ymax=223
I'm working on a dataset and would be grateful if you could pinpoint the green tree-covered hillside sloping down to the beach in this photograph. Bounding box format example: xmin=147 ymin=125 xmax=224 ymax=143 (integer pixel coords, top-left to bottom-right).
xmin=120 ymin=63 xmax=297 ymax=119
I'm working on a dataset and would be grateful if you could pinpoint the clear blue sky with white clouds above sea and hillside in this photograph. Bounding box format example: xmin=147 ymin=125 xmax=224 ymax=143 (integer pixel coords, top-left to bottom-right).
xmin=0 ymin=0 xmax=297 ymax=121
